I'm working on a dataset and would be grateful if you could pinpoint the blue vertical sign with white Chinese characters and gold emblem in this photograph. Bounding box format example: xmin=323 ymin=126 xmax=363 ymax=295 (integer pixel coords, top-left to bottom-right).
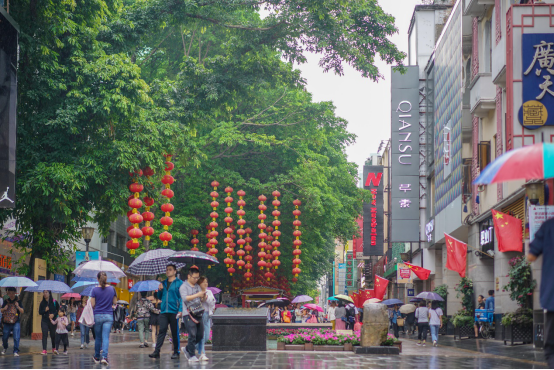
xmin=519 ymin=33 xmax=554 ymax=130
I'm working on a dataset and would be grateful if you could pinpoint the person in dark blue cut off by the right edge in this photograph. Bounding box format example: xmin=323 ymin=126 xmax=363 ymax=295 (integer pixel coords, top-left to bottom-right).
xmin=528 ymin=219 xmax=554 ymax=369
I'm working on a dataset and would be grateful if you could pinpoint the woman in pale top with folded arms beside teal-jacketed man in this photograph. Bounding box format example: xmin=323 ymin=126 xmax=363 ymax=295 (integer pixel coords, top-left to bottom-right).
xmin=180 ymin=267 xmax=207 ymax=363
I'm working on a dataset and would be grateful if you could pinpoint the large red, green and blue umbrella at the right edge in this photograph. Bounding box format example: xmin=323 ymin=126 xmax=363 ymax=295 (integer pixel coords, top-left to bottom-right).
xmin=474 ymin=143 xmax=554 ymax=185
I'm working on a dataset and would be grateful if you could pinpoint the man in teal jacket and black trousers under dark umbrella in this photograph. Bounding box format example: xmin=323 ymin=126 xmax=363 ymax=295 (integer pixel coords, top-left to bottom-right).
xmin=148 ymin=264 xmax=183 ymax=360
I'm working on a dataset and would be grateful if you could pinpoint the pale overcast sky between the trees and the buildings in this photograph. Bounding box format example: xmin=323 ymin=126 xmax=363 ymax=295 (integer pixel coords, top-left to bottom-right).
xmin=288 ymin=0 xmax=414 ymax=179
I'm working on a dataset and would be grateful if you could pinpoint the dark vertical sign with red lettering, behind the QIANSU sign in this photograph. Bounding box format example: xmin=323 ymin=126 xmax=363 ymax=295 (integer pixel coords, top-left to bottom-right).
xmin=363 ymin=166 xmax=385 ymax=256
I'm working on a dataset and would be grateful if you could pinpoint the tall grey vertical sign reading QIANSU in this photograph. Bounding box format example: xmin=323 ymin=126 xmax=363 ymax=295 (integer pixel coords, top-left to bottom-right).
xmin=390 ymin=66 xmax=420 ymax=243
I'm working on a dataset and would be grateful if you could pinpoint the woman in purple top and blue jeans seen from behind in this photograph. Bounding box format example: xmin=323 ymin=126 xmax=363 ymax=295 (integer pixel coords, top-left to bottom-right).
xmin=90 ymin=272 xmax=117 ymax=366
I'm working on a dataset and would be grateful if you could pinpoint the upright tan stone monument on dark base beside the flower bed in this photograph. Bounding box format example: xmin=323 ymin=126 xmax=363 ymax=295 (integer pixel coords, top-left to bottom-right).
xmin=356 ymin=302 xmax=400 ymax=355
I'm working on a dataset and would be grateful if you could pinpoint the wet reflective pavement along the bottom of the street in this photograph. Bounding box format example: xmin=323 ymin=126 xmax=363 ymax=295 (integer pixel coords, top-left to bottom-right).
xmin=0 ymin=333 xmax=546 ymax=369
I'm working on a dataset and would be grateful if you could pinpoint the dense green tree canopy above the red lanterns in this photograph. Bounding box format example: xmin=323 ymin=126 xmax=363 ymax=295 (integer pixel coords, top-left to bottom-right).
xmin=2 ymin=0 xmax=405 ymax=292
